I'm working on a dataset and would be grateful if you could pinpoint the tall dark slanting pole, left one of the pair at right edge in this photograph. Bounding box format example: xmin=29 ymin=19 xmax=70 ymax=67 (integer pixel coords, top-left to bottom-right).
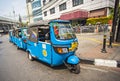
xmin=109 ymin=0 xmax=119 ymax=47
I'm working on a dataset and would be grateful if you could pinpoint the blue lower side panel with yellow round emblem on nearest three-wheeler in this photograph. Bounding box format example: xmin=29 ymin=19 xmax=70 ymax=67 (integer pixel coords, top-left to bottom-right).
xmin=27 ymin=40 xmax=51 ymax=64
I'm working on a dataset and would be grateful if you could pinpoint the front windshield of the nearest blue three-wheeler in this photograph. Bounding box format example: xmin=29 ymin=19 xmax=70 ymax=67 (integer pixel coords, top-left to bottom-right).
xmin=54 ymin=23 xmax=76 ymax=40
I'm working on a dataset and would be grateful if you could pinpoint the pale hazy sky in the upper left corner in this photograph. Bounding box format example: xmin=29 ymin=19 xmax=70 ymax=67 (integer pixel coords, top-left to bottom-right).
xmin=0 ymin=0 xmax=27 ymax=18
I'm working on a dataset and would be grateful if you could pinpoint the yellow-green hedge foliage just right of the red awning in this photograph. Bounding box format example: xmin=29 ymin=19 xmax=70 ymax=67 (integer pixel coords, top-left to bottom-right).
xmin=87 ymin=17 xmax=111 ymax=25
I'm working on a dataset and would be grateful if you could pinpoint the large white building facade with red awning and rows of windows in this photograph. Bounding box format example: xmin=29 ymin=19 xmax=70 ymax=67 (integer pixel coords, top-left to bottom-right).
xmin=41 ymin=0 xmax=114 ymax=25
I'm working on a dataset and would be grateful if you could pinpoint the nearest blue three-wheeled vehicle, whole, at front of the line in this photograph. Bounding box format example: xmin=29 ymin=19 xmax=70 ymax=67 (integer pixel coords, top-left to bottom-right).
xmin=27 ymin=20 xmax=80 ymax=74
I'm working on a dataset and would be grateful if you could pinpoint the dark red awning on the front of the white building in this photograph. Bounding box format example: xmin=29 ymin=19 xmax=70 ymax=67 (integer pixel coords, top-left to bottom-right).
xmin=60 ymin=10 xmax=88 ymax=20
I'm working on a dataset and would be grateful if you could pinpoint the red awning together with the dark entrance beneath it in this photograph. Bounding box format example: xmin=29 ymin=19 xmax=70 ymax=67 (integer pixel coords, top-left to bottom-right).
xmin=60 ymin=10 xmax=88 ymax=26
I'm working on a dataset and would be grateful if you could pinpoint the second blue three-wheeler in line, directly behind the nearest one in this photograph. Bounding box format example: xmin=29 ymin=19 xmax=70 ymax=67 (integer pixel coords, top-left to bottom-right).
xmin=15 ymin=27 xmax=27 ymax=50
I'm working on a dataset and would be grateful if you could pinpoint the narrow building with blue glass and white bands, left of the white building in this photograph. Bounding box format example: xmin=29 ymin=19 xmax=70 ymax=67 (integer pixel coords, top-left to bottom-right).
xmin=32 ymin=0 xmax=42 ymax=22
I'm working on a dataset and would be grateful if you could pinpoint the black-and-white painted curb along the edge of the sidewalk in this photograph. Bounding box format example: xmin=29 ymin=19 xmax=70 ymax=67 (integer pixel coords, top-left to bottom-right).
xmin=80 ymin=59 xmax=120 ymax=68
